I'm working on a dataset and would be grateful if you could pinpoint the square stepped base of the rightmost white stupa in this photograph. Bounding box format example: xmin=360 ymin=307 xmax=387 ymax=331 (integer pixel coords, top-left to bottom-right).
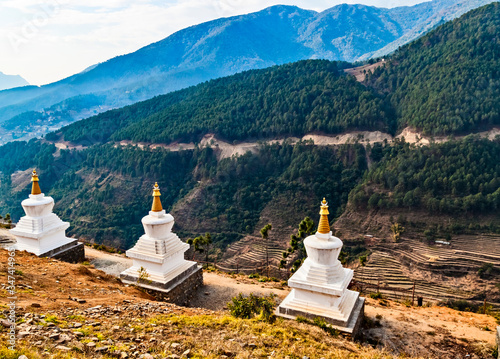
xmin=275 ymin=297 xmax=365 ymax=339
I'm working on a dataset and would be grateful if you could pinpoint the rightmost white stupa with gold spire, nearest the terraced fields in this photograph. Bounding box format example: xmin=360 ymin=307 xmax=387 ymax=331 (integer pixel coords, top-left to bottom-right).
xmin=276 ymin=199 xmax=365 ymax=336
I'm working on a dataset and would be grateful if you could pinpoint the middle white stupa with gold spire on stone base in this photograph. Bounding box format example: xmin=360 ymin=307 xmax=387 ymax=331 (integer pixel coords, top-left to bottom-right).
xmin=120 ymin=183 xmax=203 ymax=302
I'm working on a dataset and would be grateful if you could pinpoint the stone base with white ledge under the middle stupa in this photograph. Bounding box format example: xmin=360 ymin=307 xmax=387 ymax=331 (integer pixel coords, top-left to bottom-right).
xmin=120 ymin=262 xmax=203 ymax=305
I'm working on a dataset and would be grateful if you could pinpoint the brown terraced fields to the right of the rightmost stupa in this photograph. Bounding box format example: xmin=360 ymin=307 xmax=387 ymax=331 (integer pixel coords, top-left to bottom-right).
xmin=355 ymin=234 xmax=500 ymax=307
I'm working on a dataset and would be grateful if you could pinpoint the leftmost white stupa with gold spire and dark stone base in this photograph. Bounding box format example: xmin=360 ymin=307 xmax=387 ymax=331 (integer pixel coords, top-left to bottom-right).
xmin=10 ymin=170 xmax=85 ymax=262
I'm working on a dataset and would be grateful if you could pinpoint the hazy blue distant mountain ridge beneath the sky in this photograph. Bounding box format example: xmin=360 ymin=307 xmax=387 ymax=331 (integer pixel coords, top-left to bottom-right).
xmin=0 ymin=0 xmax=492 ymax=141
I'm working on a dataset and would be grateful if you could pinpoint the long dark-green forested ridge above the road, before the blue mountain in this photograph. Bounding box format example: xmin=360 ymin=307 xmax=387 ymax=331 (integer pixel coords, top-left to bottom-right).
xmin=58 ymin=60 xmax=394 ymax=144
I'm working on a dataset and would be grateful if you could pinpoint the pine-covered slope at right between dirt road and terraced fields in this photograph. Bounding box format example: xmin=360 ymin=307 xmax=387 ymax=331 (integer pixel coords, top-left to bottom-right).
xmin=350 ymin=136 xmax=500 ymax=215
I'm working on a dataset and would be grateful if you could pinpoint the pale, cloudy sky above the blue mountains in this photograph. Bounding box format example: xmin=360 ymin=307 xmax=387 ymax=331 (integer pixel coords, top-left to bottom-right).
xmin=0 ymin=0 xmax=424 ymax=85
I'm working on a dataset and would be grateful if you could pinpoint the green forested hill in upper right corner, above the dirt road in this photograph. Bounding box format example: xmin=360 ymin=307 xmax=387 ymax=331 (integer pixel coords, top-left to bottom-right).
xmin=366 ymin=2 xmax=500 ymax=135
